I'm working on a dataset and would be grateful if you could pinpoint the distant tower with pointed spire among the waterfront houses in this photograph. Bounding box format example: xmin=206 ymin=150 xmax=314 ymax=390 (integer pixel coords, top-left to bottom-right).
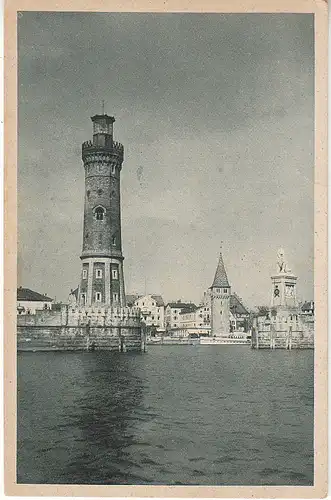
xmin=209 ymin=250 xmax=231 ymax=337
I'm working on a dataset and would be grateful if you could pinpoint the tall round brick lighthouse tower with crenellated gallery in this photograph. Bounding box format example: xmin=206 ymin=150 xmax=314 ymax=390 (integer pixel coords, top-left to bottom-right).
xmin=78 ymin=114 xmax=125 ymax=307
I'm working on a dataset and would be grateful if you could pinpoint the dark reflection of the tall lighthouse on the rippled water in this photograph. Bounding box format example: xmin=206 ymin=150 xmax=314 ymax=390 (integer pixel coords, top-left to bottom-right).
xmin=60 ymin=353 xmax=142 ymax=484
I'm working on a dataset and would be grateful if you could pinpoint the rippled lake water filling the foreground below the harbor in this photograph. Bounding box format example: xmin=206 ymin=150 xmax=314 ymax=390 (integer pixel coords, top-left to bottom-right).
xmin=17 ymin=346 xmax=314 ymax=485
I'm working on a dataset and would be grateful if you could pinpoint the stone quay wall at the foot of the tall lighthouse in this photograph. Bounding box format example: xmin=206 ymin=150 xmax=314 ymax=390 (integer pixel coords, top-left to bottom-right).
xmin=17 ymin=306 xmax=145 ymax=352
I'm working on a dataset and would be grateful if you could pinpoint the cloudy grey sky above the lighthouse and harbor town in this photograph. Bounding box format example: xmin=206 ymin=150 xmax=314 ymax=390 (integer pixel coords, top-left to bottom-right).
xmin=18 ymin=12 xmax=314 ymax=307
